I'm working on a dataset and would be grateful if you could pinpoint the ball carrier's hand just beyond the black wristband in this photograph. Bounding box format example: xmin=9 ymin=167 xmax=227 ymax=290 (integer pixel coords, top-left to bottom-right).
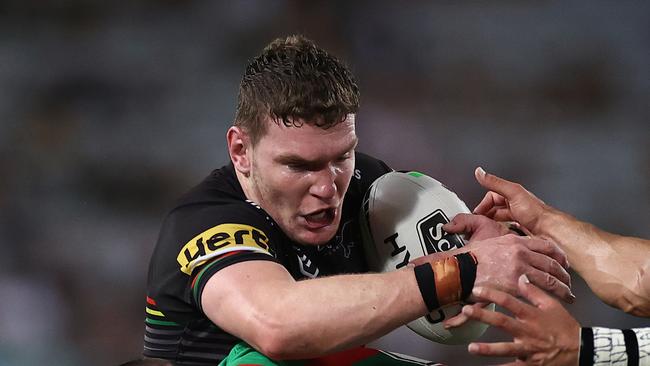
xmin=463 ymin=234 xmax=575 ymax=303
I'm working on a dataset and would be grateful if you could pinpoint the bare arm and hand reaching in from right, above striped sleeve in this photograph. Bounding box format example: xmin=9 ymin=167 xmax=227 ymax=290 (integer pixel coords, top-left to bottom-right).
xmin=474 ymin=168 xmax=650 ymax=317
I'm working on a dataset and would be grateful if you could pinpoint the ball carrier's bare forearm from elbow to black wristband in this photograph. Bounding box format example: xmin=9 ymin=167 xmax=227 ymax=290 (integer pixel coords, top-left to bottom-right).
xmin=264 ymin=268 xmax=426 ymax=358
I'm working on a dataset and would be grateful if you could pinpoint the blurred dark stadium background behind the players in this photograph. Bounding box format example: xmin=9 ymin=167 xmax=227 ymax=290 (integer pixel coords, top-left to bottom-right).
xmin=0 ymin=0 xmax=650 ymax=366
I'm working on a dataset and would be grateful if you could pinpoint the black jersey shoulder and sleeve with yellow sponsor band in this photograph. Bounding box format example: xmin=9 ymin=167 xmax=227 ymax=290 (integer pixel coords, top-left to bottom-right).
xmin=152 ymin=170 xmax=280 ymax=276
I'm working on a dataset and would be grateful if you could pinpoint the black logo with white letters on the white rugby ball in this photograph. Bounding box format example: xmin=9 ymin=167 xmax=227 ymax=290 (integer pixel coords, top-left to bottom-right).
xmin=416 ymin=210 xmax=465 ymax=254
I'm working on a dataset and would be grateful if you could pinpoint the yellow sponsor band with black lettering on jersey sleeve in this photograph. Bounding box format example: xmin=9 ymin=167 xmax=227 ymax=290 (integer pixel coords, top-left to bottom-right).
xmin=176 ymin=224 xmax=272 ymax=275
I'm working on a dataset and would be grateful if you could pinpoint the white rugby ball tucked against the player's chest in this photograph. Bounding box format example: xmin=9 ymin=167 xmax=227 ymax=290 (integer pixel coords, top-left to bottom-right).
xmin=360 ymin=172 xmax=494 ymax=344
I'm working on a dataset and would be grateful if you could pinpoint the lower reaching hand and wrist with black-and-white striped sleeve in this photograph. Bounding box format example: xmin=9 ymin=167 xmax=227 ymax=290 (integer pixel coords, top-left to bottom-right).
xmin=463 ymin=276 xmax=650 ymax=366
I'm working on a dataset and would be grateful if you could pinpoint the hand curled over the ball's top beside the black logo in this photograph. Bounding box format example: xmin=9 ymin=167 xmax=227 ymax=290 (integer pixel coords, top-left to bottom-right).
xmin=442 ymin=213 xmax=510 ymax=242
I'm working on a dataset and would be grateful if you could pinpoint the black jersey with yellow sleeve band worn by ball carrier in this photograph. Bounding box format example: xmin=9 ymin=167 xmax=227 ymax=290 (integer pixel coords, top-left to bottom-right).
xmin=144 ymin=153 xmax=390 ymax=366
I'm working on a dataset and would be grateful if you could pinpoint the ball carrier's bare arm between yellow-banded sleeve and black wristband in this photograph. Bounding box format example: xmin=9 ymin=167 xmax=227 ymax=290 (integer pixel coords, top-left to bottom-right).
xmin=201 ymin=261 xmax=427 ymax=359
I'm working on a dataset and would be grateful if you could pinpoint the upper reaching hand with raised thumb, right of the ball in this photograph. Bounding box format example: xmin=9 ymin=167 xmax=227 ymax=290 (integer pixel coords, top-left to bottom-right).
xmin=474 ymin=167 xmax=554 ymax=234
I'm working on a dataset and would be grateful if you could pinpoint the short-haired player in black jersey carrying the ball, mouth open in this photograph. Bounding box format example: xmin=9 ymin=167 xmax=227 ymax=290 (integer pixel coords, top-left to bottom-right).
xmin=144 ymin=36 xmax=573 ymax=365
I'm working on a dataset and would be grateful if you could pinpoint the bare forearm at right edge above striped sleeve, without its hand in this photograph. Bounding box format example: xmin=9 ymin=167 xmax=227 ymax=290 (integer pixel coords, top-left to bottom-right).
xmin=533 ymin=210 xmax=650 ymax=317
